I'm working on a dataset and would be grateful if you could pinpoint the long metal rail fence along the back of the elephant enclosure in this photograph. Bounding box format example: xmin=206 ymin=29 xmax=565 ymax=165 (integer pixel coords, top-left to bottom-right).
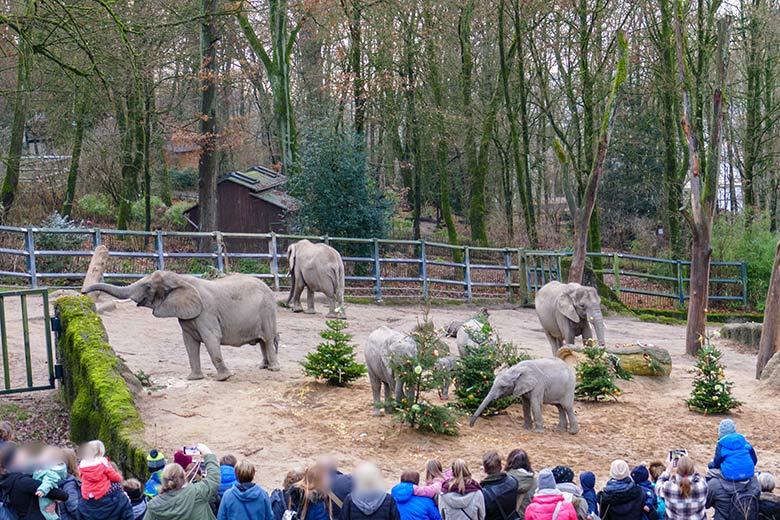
xmin=0 ymin=227 xmax=747 ymax=306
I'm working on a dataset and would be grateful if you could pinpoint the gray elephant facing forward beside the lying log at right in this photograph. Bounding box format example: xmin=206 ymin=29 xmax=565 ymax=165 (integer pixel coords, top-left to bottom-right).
xmin=534 ymin=281 xmax=605 ymax=355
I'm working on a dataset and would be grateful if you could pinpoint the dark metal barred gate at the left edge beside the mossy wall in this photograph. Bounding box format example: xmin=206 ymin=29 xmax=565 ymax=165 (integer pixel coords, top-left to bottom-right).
xmin=0 ymin=289 xmax=59 ymax=395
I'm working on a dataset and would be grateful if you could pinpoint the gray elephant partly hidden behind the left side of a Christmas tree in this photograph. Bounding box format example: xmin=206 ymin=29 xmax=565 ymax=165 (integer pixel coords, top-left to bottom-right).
xmin=363 ymin=326 xmax=417 ymax=415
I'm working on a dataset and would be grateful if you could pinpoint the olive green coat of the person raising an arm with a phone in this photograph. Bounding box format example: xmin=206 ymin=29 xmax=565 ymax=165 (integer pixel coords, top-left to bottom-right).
xmin=144 ymin=453 xmax=220 ymax=520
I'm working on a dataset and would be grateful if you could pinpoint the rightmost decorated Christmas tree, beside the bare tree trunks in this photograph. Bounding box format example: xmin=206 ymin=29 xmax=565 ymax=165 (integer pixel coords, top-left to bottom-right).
xmin=685 ymin=338 xmax=742 ymax=414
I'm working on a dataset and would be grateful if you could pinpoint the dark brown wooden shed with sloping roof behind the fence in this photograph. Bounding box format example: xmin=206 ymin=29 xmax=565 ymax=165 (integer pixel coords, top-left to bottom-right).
xmin=185 ymin=166 xmax=297 ymax=252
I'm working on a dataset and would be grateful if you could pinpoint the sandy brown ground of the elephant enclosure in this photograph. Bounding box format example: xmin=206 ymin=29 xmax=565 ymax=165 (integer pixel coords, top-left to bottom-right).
xmin=1 ymin=294 xmax=780 ymax=489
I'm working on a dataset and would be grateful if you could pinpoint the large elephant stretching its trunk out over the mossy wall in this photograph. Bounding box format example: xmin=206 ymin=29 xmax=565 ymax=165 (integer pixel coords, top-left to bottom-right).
xmin=82 ymin=271 xmax=279 ymax=381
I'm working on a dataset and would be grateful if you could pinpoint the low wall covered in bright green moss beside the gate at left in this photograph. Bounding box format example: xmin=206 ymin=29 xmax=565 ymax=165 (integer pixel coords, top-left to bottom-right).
xmin=54 ymin=296 xmax=149 ymax=478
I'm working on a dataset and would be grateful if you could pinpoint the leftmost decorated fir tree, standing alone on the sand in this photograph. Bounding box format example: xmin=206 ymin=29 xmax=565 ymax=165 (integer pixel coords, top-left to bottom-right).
xmin=301 ymin=320 xmax=366 ymax=386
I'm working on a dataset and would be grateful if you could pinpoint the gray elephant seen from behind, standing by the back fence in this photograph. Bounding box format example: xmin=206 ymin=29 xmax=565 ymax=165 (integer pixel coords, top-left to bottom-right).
xmin=287 ymin=240 xmax=346 ymax=318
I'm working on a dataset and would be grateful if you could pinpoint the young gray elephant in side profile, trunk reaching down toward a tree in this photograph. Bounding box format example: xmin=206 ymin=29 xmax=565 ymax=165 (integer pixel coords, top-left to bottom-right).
xmin=469 ymin=358 xmax=580 ymax=434
